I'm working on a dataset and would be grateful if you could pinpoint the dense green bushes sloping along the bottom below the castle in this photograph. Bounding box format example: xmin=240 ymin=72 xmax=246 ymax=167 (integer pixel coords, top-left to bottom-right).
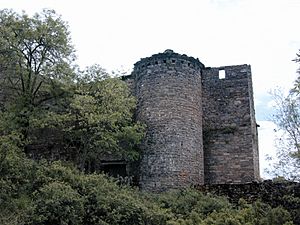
xmin=0 ymin=145 xmax=293 ymax=225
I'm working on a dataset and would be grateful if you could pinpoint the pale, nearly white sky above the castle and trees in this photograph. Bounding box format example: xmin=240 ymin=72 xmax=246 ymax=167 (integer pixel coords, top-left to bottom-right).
xmin=0 ymin=0 xmax=300 ymax=179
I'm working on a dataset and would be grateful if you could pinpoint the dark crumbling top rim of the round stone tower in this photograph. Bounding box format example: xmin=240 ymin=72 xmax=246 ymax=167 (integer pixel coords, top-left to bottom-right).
xmin=134 ymin=49 xmax=205 ymax=69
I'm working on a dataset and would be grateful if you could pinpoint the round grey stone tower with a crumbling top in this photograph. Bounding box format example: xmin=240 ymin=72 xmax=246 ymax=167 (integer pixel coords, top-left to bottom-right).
xmin=133 ymin=50 xmax=204 ymax=191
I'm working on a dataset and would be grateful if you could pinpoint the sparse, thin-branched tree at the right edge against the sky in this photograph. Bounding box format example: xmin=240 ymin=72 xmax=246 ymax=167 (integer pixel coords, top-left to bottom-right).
xmin=269 ymin=51 xmax=300 ymax=181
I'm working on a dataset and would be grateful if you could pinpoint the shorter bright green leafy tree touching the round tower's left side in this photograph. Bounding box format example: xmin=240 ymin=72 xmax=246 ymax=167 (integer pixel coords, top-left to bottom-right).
xmin=57 ymin=66 xmax=144 ymax=171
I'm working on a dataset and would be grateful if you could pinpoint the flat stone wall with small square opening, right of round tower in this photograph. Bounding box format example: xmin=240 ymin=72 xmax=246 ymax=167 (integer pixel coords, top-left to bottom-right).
xmin=202 ymin=65 xmax=259 ymax=184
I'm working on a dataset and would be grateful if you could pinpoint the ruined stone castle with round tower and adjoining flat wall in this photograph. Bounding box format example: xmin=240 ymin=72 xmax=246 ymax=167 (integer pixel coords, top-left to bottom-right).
xmin=124 ymin=50 xmax=259 ymax=191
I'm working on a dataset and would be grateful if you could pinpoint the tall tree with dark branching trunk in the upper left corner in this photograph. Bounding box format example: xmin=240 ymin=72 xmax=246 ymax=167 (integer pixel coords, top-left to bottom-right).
xmin=0 ymin=10 xmax=74 ymax=139
